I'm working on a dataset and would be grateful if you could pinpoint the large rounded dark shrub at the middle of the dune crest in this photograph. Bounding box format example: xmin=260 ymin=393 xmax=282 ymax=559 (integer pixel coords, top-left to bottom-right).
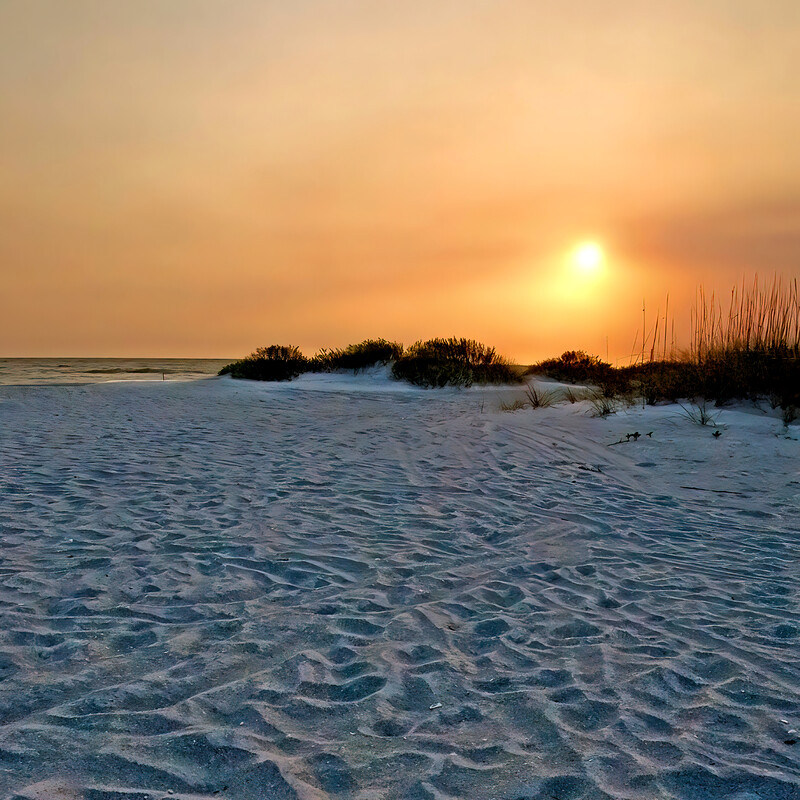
xmin=392 ymin=337 xmax=521 ymax=388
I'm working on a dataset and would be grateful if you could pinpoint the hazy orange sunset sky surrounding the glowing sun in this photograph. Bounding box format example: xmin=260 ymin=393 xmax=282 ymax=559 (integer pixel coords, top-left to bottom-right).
xmin=0 ymin=0 xmax=800 ymax=363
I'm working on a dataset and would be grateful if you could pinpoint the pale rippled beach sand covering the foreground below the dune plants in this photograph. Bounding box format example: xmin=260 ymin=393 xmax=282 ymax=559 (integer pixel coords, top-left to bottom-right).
xmin=0 ymin=376 xmax=800 ymax=800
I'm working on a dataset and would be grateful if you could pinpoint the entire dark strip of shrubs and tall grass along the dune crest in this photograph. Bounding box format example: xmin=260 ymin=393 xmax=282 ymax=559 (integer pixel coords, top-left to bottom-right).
xmin=220 ymin=277 xmax=800 ymax=421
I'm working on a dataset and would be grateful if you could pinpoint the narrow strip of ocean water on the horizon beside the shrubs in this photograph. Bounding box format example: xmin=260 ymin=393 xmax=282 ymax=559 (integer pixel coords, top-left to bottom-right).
xmin=0 ymin=358 xmax=233 ymax=386
